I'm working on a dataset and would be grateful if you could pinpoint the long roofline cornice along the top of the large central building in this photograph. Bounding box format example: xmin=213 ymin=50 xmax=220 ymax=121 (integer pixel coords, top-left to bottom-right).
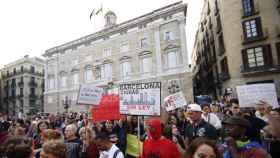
xmin=43 ymin=1 xmax=187 ymax=57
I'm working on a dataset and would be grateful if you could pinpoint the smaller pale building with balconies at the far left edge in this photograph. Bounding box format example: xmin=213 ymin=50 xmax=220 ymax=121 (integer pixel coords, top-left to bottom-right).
xmin=1 ymin=56 xmax=45 ymax=116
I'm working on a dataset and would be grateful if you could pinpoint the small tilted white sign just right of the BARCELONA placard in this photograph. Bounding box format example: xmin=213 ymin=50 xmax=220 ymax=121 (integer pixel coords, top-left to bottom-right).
xmin=164 ymin=92 xmax=187 ymax=111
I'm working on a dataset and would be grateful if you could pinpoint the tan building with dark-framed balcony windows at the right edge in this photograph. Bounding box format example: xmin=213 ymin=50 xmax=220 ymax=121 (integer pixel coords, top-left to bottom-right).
xmin=192 ymin=0 xmax=280 ymax=98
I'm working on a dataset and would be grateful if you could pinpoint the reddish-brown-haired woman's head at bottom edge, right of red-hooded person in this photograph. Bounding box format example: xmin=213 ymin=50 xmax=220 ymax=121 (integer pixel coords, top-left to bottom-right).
xmin=187 ymin=138 xmax=222 ymax=158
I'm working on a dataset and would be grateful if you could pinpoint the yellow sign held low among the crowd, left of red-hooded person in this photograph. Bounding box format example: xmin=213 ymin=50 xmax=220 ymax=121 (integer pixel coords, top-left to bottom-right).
xmin=126 ymin=134 xmax=143 ymax=157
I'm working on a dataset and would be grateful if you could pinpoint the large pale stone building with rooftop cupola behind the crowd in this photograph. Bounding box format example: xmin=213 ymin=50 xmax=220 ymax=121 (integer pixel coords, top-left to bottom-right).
xmin=44 ymin=2 xmax=192 ymax=113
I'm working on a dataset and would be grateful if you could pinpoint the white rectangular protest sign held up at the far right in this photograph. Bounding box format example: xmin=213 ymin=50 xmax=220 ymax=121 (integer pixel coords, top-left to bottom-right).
xmin=236 ymin=83 xmax=279 ymax=107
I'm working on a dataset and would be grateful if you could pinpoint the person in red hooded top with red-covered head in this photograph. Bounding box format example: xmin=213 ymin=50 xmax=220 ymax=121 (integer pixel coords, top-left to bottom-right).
xmin=142 ymin=119 xmax=180 ymax=158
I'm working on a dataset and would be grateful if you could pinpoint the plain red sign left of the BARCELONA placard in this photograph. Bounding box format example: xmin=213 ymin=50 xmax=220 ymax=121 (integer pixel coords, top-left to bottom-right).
xmin=91 ymin=95 xmax=121 ymax=121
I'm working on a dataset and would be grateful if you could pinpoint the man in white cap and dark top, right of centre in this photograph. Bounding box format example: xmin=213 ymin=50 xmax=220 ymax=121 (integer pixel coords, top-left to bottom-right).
xmin=184 ymin=104 xmax=217 ymax=143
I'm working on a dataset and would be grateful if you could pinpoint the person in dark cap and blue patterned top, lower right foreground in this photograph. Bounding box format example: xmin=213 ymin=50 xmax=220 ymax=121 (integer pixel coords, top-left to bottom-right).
xmin=219 ymin=116 xmax=270 ymax=158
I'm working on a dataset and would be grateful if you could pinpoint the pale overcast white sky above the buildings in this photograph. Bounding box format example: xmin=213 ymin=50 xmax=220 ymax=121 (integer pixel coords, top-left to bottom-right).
xmin=0 ymin=0 xmax=203 ymax=68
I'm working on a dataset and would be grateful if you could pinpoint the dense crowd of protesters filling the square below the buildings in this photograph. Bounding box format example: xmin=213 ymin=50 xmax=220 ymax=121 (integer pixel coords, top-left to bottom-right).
xmin=0 ymin=96 xmax=280 ymax=158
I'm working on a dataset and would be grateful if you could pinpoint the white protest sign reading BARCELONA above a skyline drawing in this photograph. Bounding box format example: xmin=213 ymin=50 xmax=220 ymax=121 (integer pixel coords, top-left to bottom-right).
xmin=119 ymin=82 xmax=161 ymax=116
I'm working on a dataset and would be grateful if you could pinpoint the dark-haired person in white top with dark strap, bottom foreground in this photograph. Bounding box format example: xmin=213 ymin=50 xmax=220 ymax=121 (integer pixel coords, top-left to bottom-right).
xmin=95 ymin=132 xmax=124 ymax=158
